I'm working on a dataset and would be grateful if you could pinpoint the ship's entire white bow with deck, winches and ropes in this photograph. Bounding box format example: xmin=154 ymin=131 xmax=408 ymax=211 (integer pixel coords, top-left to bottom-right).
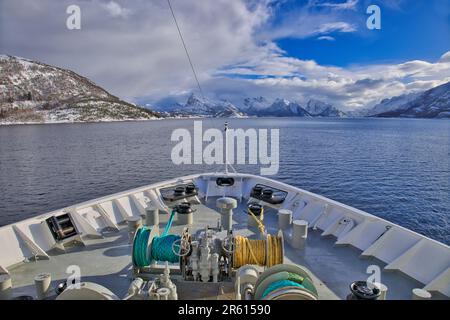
xmin=0 ymin=172 xmax=450 ymax=300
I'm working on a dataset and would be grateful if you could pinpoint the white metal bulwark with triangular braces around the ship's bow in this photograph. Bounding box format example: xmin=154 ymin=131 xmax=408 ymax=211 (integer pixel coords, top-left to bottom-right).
xmin=0 ymin=173 xmax=450 ymax=296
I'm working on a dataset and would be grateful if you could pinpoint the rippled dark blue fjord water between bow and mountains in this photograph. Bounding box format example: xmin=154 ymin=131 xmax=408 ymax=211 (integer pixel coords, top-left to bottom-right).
xmin=0 ymin=118 xmax=450 ymax=244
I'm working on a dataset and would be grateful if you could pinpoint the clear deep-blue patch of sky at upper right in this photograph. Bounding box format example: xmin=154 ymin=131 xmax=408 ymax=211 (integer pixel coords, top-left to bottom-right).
xmin=275 ymin=0 xmax=450 ymax=67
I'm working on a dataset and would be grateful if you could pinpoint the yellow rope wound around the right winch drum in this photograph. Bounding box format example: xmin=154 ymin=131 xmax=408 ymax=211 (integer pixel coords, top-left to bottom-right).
xmin=233 ymin=234 xmax=283 ymax=268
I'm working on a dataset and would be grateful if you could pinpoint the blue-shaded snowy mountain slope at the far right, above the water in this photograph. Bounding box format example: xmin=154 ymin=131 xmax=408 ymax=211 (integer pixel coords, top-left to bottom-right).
xmin=368 ymin=82 xmax=450 ymax=118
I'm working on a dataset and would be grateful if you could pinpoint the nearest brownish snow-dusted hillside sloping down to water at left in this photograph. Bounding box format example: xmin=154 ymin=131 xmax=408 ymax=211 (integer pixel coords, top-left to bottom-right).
xmin=0 ymin=55 xmax=160 ymax=123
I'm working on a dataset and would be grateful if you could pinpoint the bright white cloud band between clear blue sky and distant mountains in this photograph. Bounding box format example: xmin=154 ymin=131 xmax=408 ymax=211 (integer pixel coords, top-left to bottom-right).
xmin=214 ymin=47 xmax=450 ymax=110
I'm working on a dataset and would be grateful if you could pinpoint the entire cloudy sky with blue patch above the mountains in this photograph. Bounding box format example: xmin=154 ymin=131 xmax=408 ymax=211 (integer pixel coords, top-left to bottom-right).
xmin=0 ymin=0 xmax=450 ymax=110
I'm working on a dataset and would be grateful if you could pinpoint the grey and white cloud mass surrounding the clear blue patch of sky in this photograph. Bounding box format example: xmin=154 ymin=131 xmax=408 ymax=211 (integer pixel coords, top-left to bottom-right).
xmin=0 ymin=0 xmax=450 ymax=109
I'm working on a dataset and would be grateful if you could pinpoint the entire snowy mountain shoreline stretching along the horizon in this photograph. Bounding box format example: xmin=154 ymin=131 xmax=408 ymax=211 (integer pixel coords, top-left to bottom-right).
xmin=0 ymin=55 xmax=450 ymax=124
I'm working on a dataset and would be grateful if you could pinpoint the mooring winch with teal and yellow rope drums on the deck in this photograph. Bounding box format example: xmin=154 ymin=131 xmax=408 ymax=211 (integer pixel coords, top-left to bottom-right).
xmin=132 ymin=198 xmax=284 ymax=282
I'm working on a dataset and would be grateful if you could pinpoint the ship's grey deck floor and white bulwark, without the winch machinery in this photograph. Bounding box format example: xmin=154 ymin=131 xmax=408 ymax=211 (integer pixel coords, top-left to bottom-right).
xmin=0 ymin=174 xmax=450 ymax=299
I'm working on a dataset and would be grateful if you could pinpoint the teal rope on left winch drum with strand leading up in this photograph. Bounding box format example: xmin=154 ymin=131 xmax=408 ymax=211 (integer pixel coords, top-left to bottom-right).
xmin=132 ymin=210 xmax=181 ymax=267
